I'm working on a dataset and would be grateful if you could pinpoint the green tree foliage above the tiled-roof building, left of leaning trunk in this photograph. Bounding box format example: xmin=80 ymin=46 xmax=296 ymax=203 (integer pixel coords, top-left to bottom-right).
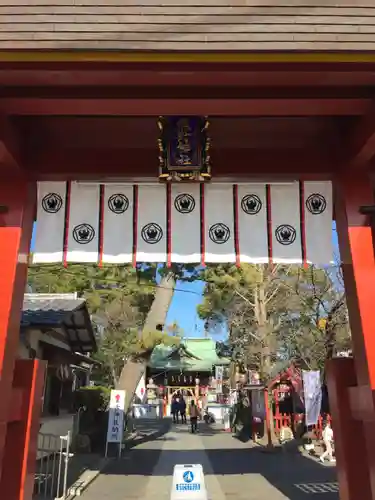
xmin=28 ymin=264 xmax=176 ymax=386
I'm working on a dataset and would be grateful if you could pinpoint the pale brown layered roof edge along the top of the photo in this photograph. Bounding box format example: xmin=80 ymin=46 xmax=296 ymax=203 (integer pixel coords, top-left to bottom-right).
xmin=0 ymin=0 xmax=375 ymax=52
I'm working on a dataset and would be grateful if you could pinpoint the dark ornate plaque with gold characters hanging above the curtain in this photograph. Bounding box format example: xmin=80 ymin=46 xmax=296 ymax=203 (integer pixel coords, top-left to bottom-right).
xmin=158 ymin=116 xmax=211 ymax=181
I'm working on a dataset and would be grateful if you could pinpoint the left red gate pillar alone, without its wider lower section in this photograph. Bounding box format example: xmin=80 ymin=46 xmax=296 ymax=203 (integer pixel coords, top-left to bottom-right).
xmin=0 ymin=179 xmax=36 ymax=492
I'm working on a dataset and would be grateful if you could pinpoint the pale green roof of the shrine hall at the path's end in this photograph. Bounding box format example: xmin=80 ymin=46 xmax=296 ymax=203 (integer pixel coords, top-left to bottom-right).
xmin=148 ymin=339 xmax=230 ymax=372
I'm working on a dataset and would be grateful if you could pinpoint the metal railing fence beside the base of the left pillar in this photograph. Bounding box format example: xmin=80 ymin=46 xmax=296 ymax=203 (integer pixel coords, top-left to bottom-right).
xmin=34 ymin=431 xmax=73 ymax=500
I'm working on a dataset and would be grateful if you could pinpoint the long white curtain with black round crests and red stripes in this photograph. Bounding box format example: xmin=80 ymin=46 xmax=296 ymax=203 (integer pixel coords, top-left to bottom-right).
xmin=33 ymin=181 xmax=333 ymax=265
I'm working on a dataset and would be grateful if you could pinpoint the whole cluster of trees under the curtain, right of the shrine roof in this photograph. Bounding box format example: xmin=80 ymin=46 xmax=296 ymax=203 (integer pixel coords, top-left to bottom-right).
xmin=198 ymin=264 xmax=350 ymax=379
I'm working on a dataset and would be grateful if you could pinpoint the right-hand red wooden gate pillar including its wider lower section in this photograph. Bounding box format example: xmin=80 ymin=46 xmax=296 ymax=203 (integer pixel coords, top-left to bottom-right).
xmin=327 ymin=172 xmax=375 ymax=500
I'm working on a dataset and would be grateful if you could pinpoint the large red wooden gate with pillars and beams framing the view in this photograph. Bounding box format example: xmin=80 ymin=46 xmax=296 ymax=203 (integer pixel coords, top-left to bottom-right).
xmin=0 ymin=53 xmax=375 ymax=500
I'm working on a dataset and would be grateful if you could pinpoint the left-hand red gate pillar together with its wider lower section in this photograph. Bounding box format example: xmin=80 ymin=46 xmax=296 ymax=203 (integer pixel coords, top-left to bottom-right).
xmin=0 ymin=179 xmax=45 ymax=500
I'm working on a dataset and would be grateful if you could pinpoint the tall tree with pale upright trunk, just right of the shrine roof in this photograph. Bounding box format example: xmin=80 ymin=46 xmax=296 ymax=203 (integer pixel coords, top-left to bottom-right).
xmin=198 ymin=264 xmax=294 ymax=377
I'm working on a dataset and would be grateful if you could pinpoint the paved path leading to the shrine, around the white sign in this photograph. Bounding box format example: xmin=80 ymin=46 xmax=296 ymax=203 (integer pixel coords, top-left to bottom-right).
xmin=81 ymin=420 xmax=339 ymax=500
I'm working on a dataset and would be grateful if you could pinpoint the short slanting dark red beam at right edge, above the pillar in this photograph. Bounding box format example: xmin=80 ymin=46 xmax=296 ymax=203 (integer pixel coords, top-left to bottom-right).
xmin=349 ymin=102 xmax=375 ymax=168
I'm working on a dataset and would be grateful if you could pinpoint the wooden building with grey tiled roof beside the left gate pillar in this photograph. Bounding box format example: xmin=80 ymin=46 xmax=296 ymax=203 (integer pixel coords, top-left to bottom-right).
xmin=18 ymin=293 xmax=96 ymax=422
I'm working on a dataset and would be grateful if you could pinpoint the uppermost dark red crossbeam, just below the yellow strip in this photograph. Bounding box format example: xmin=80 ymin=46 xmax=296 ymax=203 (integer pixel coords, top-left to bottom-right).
xmin=0 ymin=61 xmax=375 ymax=88
